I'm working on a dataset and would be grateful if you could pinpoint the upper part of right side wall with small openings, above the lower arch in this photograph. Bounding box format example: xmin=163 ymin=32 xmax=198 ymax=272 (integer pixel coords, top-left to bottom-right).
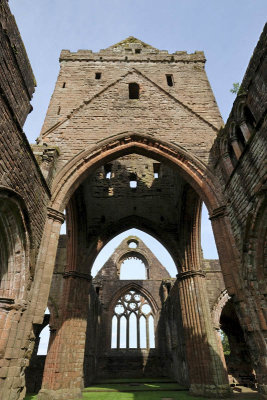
xmin=211 ymin=25 xmax=267 ymax=262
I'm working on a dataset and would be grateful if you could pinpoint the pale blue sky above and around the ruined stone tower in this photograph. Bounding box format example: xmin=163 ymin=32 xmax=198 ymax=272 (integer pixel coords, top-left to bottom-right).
xmin=9 ymin=0 xmax=267 ymax=288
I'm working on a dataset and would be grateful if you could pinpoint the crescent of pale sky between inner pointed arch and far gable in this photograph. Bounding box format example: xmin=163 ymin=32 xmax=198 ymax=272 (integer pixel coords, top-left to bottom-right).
xmin=91 ymin=228 xmax=177 ymax=279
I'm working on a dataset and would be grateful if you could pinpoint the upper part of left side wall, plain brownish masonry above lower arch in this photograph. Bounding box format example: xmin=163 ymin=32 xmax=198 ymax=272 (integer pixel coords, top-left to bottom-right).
xmin=0 ymin=1 xmax=49 ymax=251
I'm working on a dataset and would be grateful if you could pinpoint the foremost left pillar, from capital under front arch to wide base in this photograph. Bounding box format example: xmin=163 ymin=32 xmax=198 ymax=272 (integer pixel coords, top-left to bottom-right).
xmin=0 ymin=208 xmax=64 ymax=400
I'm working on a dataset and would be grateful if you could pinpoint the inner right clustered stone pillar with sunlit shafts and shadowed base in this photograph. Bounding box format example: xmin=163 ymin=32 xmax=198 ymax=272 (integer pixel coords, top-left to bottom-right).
xmin=177 ymin=270 xmax=230 ymax=398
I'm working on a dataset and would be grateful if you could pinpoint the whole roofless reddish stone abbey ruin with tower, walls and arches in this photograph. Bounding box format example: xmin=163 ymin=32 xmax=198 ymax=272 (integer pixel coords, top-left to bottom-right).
xmin=0 ymin=0 xmax=267 ymax=400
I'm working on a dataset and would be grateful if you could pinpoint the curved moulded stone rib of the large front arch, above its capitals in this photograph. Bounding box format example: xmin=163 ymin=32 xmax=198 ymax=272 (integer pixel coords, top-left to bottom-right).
xmin=51 ymin=132 xmax=223 ymax=211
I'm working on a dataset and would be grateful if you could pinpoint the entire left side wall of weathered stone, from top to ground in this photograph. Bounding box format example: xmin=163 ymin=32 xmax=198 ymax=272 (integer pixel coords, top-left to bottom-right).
xmin=0 ymin=0 xmax=50 ymax=400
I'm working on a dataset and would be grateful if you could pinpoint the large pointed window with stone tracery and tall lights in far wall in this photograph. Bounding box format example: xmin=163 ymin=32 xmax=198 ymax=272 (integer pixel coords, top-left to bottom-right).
xmin=111 ymin=290 xmax=155 ymax=349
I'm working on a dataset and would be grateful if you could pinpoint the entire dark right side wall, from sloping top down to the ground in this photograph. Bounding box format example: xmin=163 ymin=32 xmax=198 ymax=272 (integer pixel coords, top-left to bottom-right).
xmin=211 ymin=25 xmax=267 ymax=394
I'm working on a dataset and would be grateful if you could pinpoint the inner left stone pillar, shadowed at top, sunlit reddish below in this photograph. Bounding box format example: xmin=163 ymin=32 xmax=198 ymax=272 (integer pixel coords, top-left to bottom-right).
xmin=38 ymin=271 xmax=92 ymax=400
